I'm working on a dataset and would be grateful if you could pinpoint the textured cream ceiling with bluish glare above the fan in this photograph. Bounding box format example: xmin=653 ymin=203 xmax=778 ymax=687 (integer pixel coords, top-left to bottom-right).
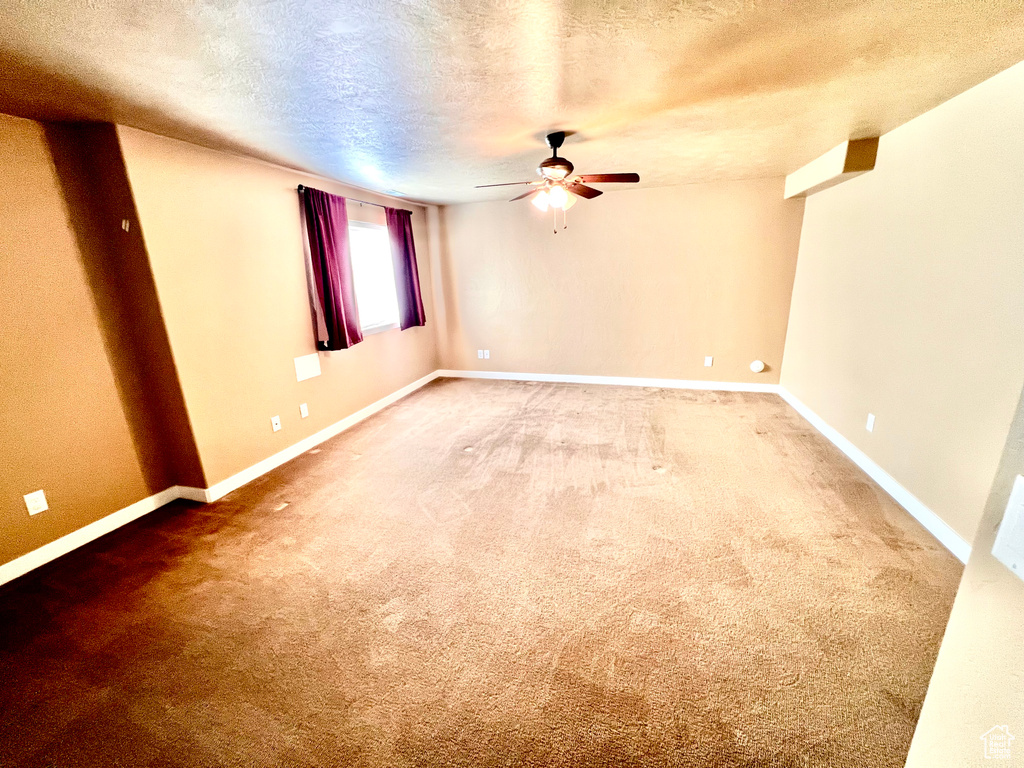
xmin=0 ymin=0 xmax=1024 ymax=202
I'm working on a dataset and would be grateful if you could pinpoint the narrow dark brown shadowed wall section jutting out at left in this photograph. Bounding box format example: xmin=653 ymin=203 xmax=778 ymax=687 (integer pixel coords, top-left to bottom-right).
xmin=46 ymin=123 xmax=206 ymax=494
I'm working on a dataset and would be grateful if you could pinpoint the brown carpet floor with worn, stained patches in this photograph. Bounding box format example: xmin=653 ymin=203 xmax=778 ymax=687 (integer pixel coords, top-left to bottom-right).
xmin=0 ymin=380 xmax=962 ymax=768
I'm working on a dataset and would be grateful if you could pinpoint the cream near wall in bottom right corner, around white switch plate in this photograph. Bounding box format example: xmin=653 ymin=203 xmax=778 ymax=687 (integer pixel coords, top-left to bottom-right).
xmin=906 ymin=382 xmax=1024 ymax=768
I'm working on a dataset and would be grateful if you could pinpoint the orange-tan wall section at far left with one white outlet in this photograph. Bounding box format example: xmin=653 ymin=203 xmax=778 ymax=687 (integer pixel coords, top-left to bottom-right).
xmin=0 ymin=115 xmax=151 ymax=563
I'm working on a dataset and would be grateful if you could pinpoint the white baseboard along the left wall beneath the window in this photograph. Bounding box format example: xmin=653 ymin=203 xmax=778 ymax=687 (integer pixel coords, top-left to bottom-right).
xmin=0 ymin=371 xmax=438 ymax=585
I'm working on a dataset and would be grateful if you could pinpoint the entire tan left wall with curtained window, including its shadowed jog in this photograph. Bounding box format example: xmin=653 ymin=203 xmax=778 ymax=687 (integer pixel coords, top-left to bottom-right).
xmin=0 ymin=116 xmax=437 ymax=564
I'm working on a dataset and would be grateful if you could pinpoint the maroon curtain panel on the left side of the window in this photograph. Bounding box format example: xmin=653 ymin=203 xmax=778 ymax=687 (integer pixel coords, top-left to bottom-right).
xmin=299 ymin=186 xmax=362 ymax=349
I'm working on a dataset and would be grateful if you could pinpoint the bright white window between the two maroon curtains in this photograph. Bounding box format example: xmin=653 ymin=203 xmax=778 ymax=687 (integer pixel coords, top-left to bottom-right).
xmin=348 ymin=221 xmax=398 ymax=333
